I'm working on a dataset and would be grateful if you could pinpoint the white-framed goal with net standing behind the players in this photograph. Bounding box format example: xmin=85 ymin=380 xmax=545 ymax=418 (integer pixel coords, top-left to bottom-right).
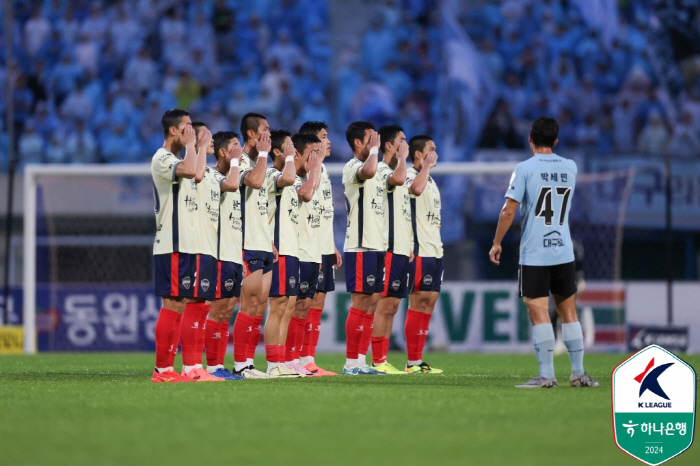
xmin=22 ymin=160 xmax=635 ymax=353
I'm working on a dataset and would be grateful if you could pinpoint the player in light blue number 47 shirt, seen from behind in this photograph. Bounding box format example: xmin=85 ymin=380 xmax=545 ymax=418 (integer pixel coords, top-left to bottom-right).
xmin=489 ymin=116 xmax=598 ymax=388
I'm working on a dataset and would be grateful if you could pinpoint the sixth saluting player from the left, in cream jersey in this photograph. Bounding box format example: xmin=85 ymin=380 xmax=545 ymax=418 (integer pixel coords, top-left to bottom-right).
xmin=285 ymin=133 xmax=330 ymax=376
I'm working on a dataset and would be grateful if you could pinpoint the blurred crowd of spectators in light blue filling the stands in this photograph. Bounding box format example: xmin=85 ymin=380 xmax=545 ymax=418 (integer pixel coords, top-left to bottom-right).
xmin=0 ymin=0 xmax=700 ymax=170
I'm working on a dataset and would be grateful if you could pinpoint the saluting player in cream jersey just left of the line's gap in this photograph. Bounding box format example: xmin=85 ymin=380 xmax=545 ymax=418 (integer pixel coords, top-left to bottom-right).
xmin=297 ymin=121 xmax=343 ymax=375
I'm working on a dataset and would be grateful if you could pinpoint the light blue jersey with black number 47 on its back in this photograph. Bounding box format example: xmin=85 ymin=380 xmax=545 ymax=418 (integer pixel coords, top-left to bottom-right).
xmin=506 ymin=154 xmax=578 ymax=265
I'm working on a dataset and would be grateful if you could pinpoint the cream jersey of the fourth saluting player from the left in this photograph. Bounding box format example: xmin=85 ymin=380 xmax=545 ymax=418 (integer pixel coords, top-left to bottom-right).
xmin=239 ymin=152 xmax=272 ymax=252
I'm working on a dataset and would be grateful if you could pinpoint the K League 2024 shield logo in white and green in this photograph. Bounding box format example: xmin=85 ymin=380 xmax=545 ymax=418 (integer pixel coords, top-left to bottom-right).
xmin=611 ymin=345 xmax=696 ymax=465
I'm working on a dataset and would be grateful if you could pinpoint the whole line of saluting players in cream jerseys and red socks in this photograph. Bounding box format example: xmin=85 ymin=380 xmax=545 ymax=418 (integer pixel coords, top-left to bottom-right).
xmin=151 ymin=110 xmax=443 ymax=383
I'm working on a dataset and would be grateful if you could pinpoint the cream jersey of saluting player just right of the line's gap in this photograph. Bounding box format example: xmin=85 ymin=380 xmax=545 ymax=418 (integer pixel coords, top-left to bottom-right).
xmin=343 ymin=158 xmax=386 ymax=251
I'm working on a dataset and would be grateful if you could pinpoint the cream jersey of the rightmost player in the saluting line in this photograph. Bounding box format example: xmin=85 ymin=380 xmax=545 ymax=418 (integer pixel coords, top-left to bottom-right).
xmin=406 ymin=167 xmax=443 ymax=259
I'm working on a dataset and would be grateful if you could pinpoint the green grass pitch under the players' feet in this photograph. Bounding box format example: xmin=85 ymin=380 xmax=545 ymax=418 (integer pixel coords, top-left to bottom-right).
xmin=0 ymin=354 xmax=700 ymax=466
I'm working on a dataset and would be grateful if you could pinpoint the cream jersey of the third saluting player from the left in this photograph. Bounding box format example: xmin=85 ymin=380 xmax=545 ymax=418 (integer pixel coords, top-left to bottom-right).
xmin=212 ymin=169 xmax=243 ymax=264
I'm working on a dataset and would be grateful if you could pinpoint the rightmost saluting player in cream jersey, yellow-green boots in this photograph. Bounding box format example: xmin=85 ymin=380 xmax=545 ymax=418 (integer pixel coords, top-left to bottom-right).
xmin=404 ymin=135 xmax=443 ymax=374
